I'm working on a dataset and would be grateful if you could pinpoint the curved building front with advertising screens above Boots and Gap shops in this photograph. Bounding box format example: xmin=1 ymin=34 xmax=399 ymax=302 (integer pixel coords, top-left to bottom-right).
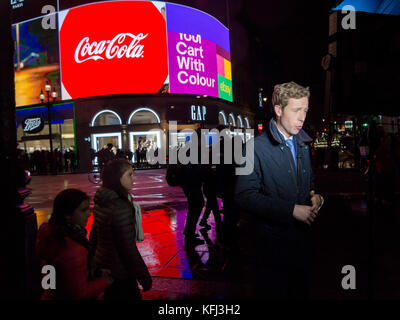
xmin=13 ymin=0 xmax=254 ymax=171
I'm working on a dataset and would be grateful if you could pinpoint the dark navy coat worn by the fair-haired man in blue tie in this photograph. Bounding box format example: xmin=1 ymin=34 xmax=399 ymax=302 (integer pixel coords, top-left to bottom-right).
xmin=235 ymin=120 xmax=314 ymax=264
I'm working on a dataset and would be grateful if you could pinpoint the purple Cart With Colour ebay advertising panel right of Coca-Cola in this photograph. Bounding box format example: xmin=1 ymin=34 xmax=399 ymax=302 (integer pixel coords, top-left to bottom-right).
xmin=166 ymin=3 xmax=232 ymax=101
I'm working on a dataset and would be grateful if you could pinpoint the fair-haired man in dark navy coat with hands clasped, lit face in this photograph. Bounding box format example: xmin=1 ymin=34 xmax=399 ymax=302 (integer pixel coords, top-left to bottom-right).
xmin=235 ymin=82 xmax=323 ymax=299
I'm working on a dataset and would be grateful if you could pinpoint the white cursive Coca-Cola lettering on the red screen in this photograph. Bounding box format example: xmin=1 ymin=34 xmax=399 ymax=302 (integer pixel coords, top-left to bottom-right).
xmin=74 ymin=33 xmax=148 ymax=63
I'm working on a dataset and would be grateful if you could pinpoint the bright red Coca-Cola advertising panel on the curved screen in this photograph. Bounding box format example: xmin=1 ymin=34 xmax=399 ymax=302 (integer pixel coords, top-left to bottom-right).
xmin=59 ymin=1 xmax=168 ymax=99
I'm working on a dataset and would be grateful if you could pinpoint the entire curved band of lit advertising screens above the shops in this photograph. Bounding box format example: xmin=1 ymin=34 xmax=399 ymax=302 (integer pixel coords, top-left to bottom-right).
xmin=13 ymin=1 xmax=233 ymax=106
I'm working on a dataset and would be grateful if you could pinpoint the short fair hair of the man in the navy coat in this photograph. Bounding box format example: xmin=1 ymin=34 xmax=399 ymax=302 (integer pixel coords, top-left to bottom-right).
xmin=272 ymin=81 xmax=310 ymax=110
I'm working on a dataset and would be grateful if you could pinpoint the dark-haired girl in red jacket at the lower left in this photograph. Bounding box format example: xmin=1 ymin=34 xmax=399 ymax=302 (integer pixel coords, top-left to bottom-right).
xmin=36 ymin=189 xmax=113 ymax=300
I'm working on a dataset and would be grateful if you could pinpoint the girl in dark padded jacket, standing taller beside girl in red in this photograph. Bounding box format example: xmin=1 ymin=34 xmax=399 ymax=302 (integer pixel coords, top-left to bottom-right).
xmin=90 ymin=159 xmax=152 ymax=299
